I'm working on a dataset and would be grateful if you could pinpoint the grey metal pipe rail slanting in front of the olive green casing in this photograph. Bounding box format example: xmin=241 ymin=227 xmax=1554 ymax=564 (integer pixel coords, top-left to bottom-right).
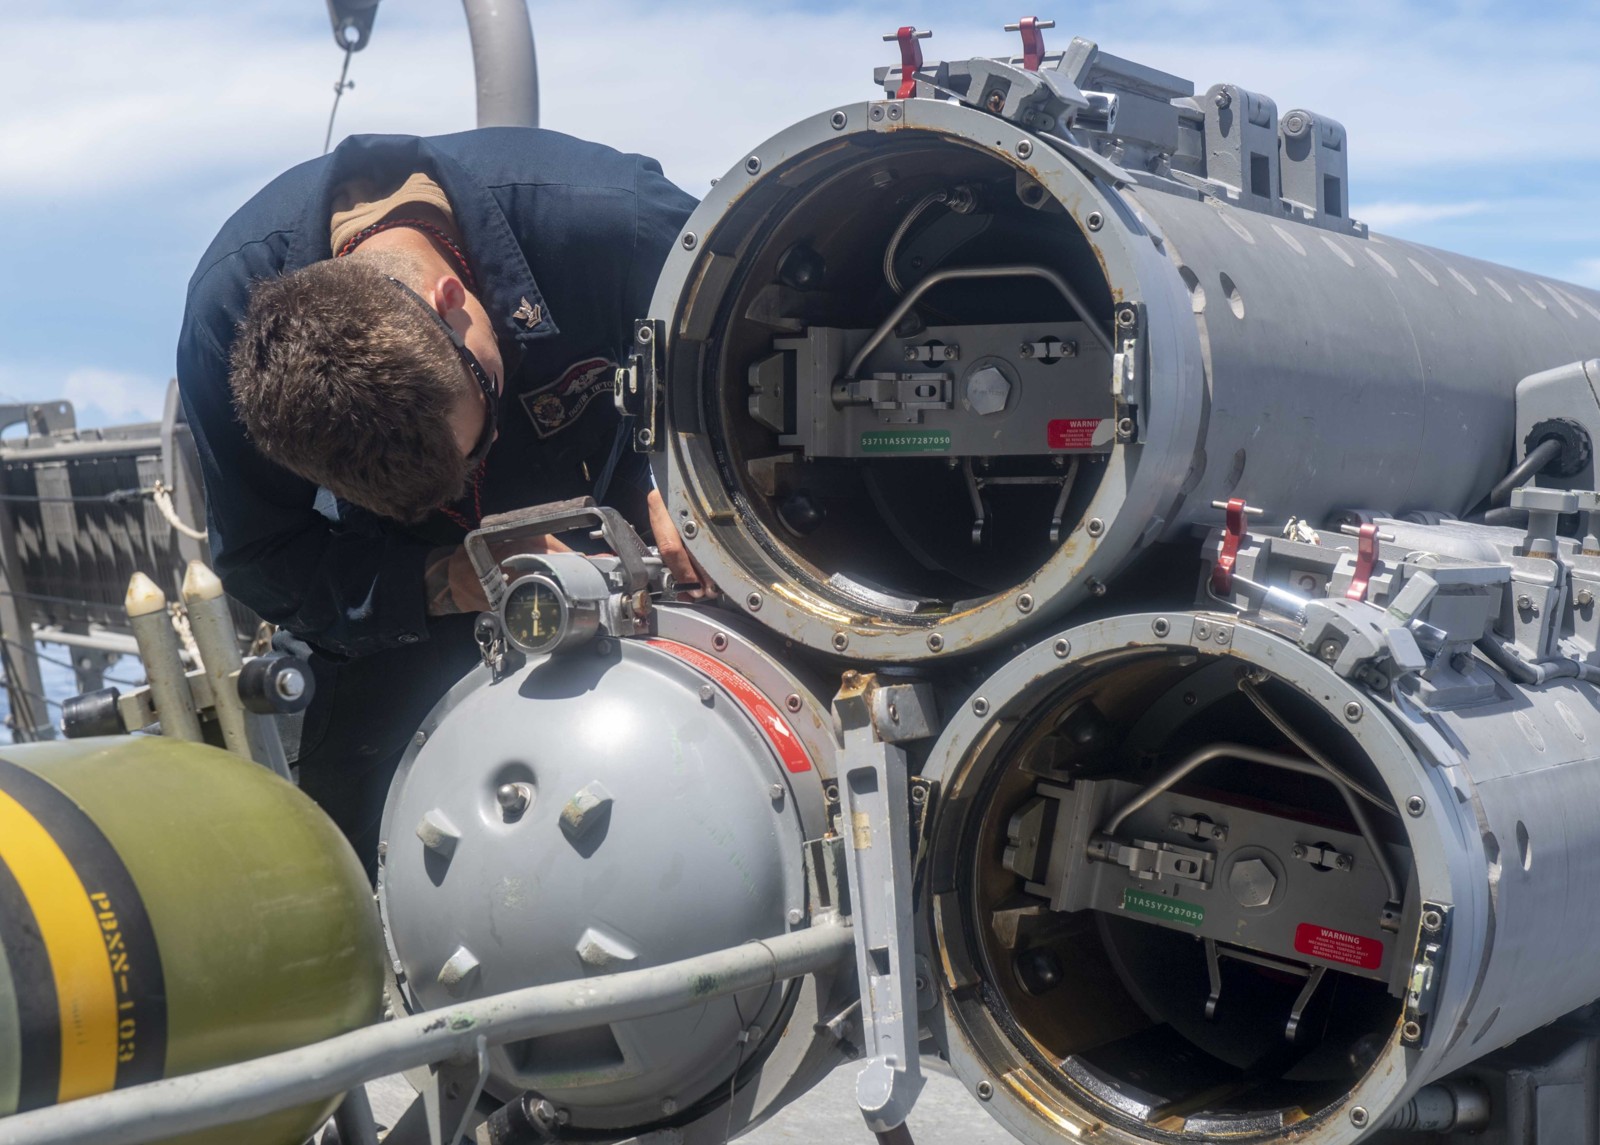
xmin=0 ymin=923 xmax=853 ymax=1145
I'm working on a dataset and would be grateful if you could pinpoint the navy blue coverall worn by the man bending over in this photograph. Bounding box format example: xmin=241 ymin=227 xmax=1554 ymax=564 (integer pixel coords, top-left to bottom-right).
xmin=178 ymin=128 xmax=694 ymax=867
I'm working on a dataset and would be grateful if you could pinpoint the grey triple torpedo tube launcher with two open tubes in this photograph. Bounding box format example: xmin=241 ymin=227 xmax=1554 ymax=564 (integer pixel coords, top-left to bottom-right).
xmin=9 ymin=21 xmax=1600 ymax=1145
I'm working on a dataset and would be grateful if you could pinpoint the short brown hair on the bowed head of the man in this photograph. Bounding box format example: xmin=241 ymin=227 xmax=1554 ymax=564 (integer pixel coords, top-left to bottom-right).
xmin=232 ymin=251 xmax=477 ymax=523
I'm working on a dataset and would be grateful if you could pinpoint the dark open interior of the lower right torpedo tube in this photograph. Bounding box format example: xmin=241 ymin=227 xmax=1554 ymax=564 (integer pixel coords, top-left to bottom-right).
xmin=941 ymin=649 xmax=1418 ymax=1140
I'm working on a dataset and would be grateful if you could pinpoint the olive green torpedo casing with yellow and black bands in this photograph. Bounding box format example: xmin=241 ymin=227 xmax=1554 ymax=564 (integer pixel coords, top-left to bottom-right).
xmin=0 ymin=736 xmax=382 ymax=1145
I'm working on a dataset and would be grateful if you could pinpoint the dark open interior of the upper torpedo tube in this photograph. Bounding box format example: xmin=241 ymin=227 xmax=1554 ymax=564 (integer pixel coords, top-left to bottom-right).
xmin=674 ymin=130 xmax=1117 ymax=622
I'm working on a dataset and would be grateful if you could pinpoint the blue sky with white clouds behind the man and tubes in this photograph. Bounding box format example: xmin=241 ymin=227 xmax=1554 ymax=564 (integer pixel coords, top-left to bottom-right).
xmin=0 ymin=0 xmax=1600 ymax=424
